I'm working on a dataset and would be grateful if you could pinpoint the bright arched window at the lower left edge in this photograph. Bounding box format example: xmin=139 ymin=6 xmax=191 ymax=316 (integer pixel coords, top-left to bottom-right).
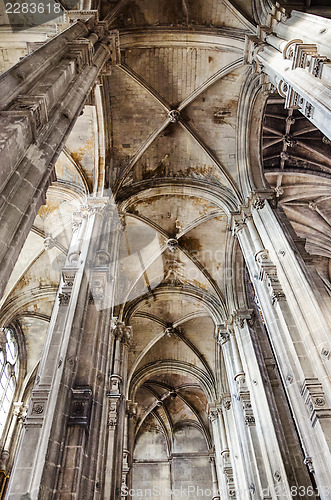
xmin=0 ymin=327 xmax=19 ymax=436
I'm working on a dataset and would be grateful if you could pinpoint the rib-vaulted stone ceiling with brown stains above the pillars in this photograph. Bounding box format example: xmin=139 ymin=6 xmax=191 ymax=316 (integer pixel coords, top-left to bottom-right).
xmin=2 ymin=0 xmax=330 ymax=458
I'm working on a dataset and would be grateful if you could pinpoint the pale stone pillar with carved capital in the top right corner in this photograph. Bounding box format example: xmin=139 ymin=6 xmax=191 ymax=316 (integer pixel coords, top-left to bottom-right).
xmin=247 ymin=6 xmax=331 ymax=139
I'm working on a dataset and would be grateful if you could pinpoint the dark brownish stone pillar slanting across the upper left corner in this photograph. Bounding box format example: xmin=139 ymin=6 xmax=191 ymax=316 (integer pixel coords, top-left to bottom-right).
xmin=0 ymin=18 xmax=119 ymax=294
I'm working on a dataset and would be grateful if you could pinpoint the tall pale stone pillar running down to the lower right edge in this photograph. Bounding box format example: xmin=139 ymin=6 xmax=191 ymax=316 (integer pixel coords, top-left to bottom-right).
xmin=233 ymin=199 xmax=331 ymax=498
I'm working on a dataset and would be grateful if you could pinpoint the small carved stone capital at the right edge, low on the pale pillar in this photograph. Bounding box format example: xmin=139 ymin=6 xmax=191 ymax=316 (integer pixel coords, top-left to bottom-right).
xmin=301 ymin=378 xmax=331 ymax=427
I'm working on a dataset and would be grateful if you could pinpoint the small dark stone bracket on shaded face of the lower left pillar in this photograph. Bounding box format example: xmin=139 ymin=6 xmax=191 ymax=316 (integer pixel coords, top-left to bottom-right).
xmin=68 ymin=386 xmax=92 ymax=428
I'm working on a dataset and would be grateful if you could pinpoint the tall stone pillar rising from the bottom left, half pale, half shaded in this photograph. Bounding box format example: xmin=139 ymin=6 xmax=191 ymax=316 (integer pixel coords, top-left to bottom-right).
xmin=8 ymin=198 xmax=121 ymax=500
